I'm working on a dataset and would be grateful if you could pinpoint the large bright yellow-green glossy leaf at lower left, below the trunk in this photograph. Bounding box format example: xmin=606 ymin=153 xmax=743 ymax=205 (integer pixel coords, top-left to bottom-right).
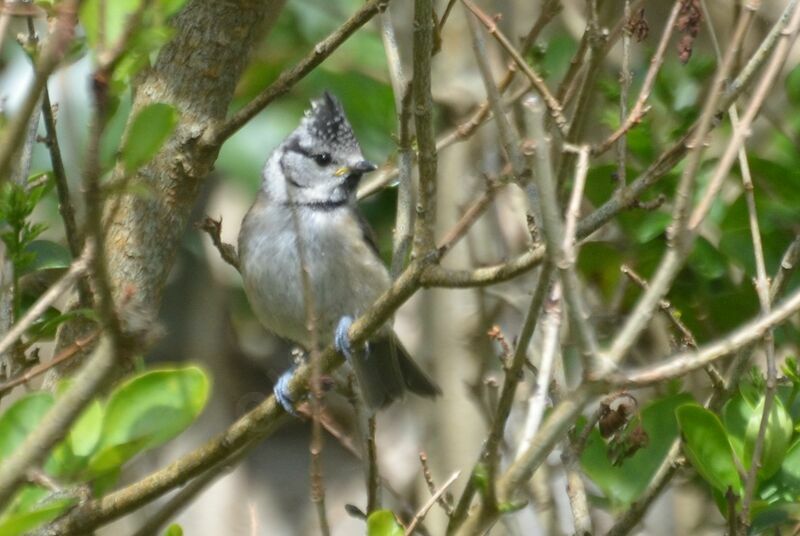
xmin=90 ymin=367 xmax=209 ymax=471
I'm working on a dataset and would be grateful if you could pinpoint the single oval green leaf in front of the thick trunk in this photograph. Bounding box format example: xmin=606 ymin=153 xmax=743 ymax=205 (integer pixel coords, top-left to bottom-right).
xmin=122 ymin=103 xmax=178 ymax=172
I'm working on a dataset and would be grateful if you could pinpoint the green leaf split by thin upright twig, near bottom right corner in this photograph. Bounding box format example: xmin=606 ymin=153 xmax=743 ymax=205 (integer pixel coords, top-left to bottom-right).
xmin=743 ymin=397 xmax=793 ymax=479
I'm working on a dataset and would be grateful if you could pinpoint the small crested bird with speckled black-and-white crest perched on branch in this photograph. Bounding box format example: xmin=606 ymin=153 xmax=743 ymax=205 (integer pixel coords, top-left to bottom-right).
xmin=238 ymin=91 xmax=441 ymax=413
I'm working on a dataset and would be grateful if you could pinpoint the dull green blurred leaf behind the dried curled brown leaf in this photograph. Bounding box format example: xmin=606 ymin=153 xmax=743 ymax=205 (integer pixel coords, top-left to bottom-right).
xmin=581 ymin=393 xmax=692 ymax=506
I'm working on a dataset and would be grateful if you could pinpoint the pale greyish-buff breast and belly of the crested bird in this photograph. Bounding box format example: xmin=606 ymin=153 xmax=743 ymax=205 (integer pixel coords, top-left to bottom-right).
xmin=239 ymin=202 xmax=390 ymax=345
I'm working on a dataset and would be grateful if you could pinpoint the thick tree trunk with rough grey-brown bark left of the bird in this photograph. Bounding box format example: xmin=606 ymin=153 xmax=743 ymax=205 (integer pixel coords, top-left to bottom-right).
xmin=53 ymin=0 xmax=285 ymax=374
